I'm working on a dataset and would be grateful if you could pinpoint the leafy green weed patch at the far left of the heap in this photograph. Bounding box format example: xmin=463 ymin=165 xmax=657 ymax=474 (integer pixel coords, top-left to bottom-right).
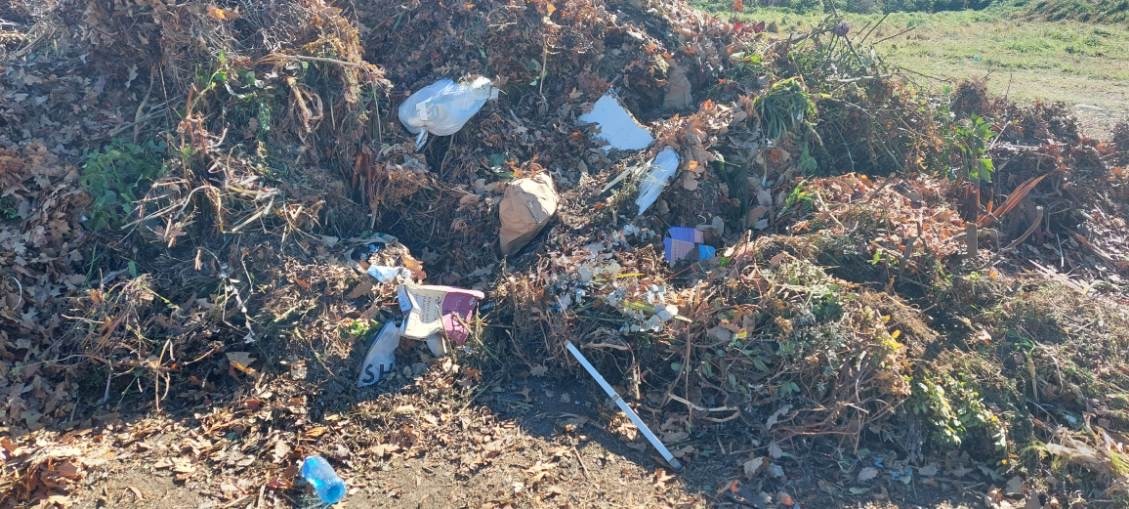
xmin=79 ymin=140 xmax=166 ymax=229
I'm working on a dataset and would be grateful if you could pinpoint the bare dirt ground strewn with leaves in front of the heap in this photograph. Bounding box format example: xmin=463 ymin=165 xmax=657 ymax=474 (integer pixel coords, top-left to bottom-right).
xmin=61 ymin=378 xmax=983 ymax=509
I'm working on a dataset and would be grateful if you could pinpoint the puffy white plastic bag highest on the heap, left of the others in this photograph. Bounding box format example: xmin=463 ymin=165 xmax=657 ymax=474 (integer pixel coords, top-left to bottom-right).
xmin=400 ymin=76 xmax=498 ymax=150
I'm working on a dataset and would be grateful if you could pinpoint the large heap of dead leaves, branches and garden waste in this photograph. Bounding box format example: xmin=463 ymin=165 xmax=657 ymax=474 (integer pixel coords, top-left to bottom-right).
xmin=0 ymin=0 xmax=1129 ymax=508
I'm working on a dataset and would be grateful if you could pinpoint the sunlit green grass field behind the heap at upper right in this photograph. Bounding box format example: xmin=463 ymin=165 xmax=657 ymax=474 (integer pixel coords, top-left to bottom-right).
xmin=703 ymin=2 xmax=1129 ymax=137
